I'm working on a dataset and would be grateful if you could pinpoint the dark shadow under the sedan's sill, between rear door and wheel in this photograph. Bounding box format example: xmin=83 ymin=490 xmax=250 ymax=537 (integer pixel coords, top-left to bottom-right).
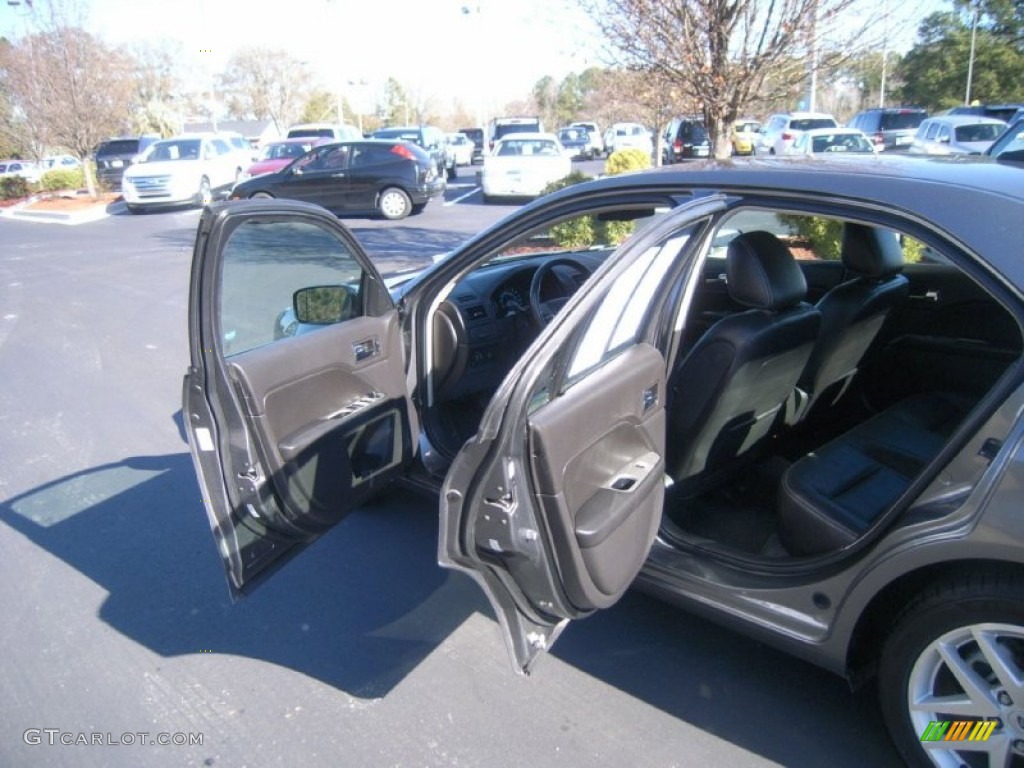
xmin=552 ymin=591 xmax=903 ymax=768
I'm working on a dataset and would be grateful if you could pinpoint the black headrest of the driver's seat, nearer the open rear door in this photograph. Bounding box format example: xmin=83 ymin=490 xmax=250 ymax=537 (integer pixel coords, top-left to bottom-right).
xmin=725 ymin=231 xmax=807 ymax=310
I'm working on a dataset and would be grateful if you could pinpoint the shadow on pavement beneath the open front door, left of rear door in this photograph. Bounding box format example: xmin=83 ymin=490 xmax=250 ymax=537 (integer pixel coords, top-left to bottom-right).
xmin=0 ymin=453 xmax=486 ymax=698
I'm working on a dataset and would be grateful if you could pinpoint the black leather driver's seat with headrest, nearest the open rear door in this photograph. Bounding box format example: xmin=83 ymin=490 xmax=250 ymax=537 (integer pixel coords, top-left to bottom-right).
xmin=667 ymin=231 xmax=820 ymax=497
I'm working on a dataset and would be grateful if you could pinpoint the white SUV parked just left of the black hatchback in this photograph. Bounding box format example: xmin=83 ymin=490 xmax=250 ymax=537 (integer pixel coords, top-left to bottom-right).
xmin=121 ymin=133 xmax=247 ymax=213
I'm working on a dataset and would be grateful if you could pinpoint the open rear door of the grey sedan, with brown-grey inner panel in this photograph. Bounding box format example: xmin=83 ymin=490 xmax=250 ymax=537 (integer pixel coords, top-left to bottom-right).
xmin=439 ymin=198 xmax=725 ymax=672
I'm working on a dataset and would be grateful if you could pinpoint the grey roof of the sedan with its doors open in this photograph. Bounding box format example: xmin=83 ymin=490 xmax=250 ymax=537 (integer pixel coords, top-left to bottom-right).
xmin=530 ymin=154 xmax=1024 ymax=286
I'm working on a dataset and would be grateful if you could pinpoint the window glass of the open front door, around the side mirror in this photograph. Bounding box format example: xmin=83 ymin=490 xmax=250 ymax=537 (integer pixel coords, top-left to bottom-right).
xmin=217 ymin=220 xmax=362 ymax=356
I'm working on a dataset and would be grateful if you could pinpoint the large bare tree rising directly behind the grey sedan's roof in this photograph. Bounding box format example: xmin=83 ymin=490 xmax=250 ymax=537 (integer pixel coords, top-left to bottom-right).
xmin=581 ymin=0 xmax=881 ymax=157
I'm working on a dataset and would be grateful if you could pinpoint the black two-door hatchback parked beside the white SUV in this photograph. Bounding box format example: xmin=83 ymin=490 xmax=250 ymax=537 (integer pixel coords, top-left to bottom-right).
xmin=229 ymin=139 xmax=445 ymax=219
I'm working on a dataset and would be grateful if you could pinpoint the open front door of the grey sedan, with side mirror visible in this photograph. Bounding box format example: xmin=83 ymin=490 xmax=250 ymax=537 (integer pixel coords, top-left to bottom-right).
xmin=182 ymin=201 xmax=417 ymax=594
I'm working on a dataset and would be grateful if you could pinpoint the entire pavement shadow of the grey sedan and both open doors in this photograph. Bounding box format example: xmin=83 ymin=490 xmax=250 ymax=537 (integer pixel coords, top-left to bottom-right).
xmin=0 ymin=436 xmax=899 ymax=767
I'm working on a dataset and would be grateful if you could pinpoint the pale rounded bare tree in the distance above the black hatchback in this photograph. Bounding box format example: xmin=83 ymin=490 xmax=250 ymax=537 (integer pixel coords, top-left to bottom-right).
xmin=220 ymin=47 xmax=313 ymax=133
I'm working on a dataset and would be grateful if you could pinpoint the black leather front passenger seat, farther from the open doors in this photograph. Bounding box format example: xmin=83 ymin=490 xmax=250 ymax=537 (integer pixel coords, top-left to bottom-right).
xmin=791 ymin=222 xmax=909 ymax=421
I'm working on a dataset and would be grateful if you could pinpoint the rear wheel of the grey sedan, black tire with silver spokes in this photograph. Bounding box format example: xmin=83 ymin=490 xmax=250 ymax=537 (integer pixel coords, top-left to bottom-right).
xmin=879 ymin=572 xmax=1024 ymax=768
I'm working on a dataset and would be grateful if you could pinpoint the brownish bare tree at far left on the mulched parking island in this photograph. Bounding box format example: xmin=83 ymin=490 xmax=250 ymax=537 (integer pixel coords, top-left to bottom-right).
xmin=4 ymin=22 xmax=133 ymax=197
